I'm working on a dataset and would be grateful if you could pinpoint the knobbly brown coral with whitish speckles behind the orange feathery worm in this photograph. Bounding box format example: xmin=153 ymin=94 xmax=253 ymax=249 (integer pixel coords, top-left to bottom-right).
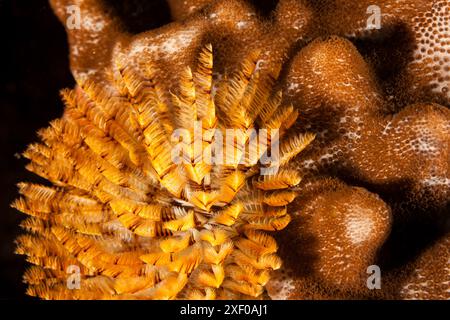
xmin=14 ymin=0 xmax=450 ymax=299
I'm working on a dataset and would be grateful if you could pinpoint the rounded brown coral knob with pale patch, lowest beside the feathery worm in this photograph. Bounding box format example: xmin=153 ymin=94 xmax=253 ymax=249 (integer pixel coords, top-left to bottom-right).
xmin=268 ymin=179 xmax=392 ymax=299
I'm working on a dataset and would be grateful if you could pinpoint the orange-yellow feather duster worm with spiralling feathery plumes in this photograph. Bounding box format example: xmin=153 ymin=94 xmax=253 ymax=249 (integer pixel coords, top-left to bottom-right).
xmin=13 ymin=45 xmax=314 ymax=299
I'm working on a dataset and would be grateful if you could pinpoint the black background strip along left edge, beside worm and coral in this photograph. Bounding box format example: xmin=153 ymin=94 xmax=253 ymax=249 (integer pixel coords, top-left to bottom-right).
xmin=0 ymin=1 xmax=74 ymax=299
